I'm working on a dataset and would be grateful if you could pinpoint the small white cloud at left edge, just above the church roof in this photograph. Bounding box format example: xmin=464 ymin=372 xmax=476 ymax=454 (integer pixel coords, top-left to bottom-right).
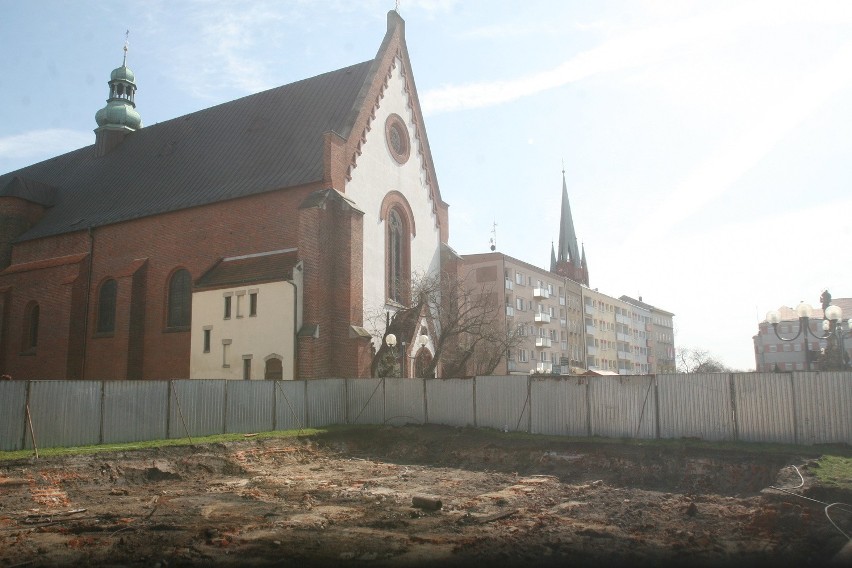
xmin=0 ymin=128 xmax=95 ymax=166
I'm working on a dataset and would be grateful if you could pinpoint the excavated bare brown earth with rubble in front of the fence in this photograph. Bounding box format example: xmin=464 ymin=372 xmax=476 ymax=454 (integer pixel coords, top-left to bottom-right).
xmin=0 ymin=426 xmax=852 ymax=568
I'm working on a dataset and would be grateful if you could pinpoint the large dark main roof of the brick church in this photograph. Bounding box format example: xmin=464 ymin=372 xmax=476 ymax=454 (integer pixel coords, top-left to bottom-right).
xmin=0 ymin=61 xmax=373 ymax=241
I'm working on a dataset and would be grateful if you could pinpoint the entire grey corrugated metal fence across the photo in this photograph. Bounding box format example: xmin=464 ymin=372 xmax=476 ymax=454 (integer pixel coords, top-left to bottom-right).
xmin=0 ymin=372 xmax=852 ymax=451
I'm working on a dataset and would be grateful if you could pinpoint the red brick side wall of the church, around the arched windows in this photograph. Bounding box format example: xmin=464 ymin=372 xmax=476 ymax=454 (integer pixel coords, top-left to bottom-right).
xmin=0 ymin=186 xmax=326 ymax=379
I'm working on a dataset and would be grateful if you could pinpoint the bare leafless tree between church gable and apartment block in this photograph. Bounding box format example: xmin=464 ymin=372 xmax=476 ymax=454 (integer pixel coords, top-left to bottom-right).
xmin=367 ymin=272 xmax=523 ymax=377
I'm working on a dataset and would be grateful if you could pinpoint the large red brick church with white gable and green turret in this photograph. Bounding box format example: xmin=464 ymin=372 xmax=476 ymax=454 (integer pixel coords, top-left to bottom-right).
xmin=0 ymin=11 xmax=449 ymax=379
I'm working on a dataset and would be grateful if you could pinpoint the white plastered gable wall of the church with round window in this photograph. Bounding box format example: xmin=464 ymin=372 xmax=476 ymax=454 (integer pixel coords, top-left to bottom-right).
xmin=346 ymin=59 xmax=441 ymax=342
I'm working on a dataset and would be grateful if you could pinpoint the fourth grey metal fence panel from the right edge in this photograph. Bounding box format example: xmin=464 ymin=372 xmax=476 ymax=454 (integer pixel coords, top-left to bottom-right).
xmin=589 ymin=375 xmax=657 ymax=439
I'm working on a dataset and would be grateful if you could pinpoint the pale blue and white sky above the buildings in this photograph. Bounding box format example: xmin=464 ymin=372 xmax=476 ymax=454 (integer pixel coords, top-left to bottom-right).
xmin=0 ymin=0 xmax=852 ymax=370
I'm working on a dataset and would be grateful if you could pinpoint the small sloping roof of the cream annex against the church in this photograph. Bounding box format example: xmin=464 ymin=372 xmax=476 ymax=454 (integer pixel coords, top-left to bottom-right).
xmin=195 ymin=249 xmax=299 ymax=288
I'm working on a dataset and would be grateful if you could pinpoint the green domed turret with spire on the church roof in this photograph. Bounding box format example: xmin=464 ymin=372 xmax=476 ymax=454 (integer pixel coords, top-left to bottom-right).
xmin=95 ymin=38 xmax=142 ymax=156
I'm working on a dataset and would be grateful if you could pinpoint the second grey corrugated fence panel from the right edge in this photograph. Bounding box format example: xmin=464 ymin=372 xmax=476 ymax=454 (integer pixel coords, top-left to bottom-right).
xmin=734 ymin=373 xmax=796 ymax=444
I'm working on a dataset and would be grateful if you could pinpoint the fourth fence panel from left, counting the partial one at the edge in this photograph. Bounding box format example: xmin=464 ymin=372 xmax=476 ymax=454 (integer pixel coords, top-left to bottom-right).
xmin=169 ymin=379 xmax=226 ymax=438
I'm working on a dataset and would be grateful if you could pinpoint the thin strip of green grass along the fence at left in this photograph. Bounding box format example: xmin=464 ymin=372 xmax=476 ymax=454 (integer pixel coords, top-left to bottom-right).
xmin=0 ymin=428 xmax=327 ymax=461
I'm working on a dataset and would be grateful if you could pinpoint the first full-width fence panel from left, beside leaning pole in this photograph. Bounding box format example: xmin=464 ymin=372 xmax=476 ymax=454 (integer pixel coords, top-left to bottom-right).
xmin=24 ymin=381 xmax=102 ymax=448
